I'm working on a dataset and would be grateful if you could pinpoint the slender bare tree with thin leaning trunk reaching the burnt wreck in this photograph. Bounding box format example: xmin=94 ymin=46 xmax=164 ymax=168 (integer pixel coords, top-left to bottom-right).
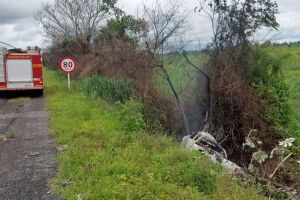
xmin=143 ymin=0 xmax=190 ymax=134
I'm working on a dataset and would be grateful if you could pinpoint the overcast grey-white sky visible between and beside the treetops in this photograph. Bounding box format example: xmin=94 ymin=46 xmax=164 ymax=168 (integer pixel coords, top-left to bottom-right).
xmin=0 ymin=0 xmax=300 ymax=48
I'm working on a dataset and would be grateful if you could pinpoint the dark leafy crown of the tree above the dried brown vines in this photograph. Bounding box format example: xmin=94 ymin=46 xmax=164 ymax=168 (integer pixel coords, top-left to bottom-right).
xmin=195 ymin=0 xmax=279 ymax=51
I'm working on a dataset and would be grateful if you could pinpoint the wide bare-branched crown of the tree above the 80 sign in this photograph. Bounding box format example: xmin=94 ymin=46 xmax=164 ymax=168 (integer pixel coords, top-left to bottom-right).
xmin=35 ymin=0 xmax=116 ymax=51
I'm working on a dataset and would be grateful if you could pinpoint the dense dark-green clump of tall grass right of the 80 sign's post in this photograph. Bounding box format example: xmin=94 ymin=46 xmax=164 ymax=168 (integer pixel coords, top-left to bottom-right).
xmin=80 ymin=76 xmax=133 ymax=103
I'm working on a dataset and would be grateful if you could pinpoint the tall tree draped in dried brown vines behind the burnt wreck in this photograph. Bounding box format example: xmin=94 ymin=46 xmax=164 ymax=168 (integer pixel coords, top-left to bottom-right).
xmin=201 ymin=0 xmax=280 ymax=164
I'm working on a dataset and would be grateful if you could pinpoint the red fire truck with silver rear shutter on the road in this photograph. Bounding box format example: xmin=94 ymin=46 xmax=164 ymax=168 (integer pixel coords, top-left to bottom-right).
xmin=0 ymin=47 xmax=44 ymax=95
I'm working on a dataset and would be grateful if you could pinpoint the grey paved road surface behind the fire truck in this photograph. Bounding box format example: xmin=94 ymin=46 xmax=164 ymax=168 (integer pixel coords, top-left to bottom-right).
xmin=0 ymin=97 xmax=56 ymax=200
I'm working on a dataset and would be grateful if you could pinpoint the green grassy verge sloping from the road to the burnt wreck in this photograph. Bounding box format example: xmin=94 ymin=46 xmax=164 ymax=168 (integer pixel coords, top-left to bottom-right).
xmin=45 ymin=69 xmax=262 ymax=200
